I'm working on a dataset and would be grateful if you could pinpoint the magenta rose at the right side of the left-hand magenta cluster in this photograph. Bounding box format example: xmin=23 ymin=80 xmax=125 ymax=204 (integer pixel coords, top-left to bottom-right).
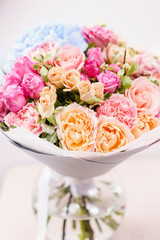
xmin=22 ymin=73 xmax=45 ymax=99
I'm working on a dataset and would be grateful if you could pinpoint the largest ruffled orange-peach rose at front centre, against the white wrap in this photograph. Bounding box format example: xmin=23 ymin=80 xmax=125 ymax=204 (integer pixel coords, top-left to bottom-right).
xmin=55 ymin=103 xmax=97 ymax=151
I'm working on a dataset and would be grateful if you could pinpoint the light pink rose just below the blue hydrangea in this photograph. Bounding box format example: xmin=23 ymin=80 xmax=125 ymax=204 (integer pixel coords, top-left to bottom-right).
xmin=54 ymin=45 xmax=85 ymax=71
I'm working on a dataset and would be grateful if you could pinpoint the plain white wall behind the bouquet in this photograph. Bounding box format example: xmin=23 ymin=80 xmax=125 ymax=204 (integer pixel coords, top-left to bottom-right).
xmin=0 ymin=0 xmax=160 ymax=184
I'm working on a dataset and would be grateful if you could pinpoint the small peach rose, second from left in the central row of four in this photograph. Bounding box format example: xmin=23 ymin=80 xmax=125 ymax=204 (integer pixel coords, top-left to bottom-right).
xmin=61 ymin=69 xmax=81 ymax=91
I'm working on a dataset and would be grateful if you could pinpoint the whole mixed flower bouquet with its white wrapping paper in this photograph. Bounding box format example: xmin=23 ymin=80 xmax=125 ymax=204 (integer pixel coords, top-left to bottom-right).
xmin=0 ymin=23 xmax=160 ymax=240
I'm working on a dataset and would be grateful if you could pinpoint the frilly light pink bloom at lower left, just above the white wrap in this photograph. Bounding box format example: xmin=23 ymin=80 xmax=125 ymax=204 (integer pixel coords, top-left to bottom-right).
xmin=5 ymin=103 xmax=42 ymax=135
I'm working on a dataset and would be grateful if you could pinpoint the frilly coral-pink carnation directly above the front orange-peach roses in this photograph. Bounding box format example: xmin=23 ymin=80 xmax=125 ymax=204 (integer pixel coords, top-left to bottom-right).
xmin=97 ymin=94 xmax=137 ymax=129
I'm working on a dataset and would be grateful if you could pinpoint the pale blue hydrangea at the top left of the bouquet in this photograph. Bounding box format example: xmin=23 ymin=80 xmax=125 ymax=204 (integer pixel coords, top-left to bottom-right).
xmin=13 ymin=22 xmax=88 ymax=58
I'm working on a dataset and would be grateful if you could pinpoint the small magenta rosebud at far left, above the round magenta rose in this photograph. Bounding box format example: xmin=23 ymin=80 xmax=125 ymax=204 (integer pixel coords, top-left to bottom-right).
xmin=3 ymin=71 xmax=22 ymax=89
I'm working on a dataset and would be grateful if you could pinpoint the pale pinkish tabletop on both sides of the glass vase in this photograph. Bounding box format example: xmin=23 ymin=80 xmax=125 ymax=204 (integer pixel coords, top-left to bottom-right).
xmin=0 ymin=158 xmax=160 ymax=240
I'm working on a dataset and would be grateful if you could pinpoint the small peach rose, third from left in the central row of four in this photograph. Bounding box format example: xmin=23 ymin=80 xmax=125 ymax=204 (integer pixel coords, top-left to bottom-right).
xmin=77 ymin=80 xmax=95 ymax=102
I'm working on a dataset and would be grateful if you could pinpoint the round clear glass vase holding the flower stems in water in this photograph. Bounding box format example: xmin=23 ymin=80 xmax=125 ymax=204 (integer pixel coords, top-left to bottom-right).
xmin=33 ymin=169 xmax=125 ymax=240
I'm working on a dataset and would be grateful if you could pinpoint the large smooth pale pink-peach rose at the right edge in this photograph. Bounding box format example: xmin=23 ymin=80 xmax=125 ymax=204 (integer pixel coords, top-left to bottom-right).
xmin=125 ymin=77 xmax=160 ymax=116
